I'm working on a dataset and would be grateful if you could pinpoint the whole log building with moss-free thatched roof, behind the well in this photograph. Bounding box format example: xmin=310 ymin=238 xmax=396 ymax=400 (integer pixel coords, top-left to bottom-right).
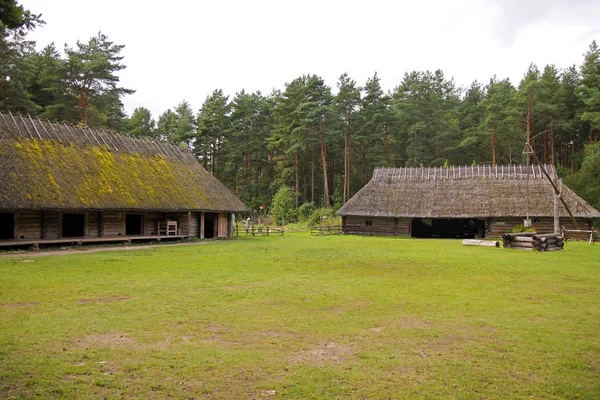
xmin=339 ymin=165 xmax=600 ymax=238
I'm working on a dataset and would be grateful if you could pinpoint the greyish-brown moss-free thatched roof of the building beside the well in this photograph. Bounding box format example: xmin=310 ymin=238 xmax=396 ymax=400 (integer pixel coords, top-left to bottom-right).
xmin=339 ymin=165 xmax=600 ymax=218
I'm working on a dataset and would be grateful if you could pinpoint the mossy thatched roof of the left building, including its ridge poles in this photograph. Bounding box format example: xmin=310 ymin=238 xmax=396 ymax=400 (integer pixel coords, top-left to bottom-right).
xmin=0 ymin=113 xmax=247 ymax=212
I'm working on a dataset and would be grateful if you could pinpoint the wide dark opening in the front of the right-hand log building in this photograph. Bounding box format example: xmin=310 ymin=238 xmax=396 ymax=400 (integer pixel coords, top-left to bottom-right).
xmin=411 ymin=218 xmax=485 ymax=239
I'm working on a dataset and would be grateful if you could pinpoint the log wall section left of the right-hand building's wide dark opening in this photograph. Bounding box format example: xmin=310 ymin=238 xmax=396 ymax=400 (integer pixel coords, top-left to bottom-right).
xmin=343 ymin=216 xmax=411 ymax=236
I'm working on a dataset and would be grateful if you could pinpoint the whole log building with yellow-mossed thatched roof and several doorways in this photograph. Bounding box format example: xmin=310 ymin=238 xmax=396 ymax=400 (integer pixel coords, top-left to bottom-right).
xmin=0 ymin=113 xmax=247 ymax=246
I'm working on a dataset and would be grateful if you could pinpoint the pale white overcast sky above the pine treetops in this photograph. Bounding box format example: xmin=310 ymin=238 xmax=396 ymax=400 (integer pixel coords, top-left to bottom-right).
xmin=19 ymin=0 xmax=600 ymax=118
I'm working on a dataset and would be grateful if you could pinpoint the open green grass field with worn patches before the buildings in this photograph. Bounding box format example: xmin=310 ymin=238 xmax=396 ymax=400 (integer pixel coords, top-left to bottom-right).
xmin=0 ymin=234 xmax=600 ymax=399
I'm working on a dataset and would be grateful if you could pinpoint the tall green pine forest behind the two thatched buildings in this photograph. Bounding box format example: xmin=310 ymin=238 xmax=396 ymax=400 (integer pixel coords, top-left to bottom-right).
xmin=0 ymin=6 xmax=600 ymax=220
